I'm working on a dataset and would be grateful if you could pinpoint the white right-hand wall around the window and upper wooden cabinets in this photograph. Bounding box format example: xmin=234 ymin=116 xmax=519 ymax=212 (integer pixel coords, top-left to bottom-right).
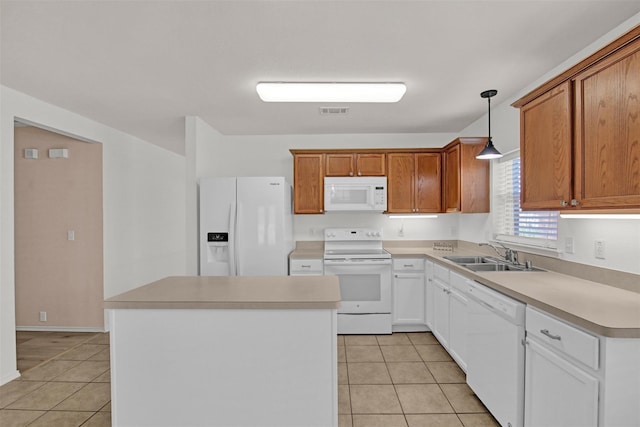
xmin=460 ymin=14 xmax=640 ymax=274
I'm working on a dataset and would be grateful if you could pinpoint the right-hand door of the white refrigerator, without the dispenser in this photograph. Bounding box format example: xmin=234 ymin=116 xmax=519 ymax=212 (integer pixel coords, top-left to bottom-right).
xmin=235 ymin=177 xmax=292 ymax=276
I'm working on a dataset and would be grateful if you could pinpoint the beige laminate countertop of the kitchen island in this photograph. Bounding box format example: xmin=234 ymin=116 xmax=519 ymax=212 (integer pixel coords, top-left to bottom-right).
xmin=104 ymin=276 xmax=340 ymax=309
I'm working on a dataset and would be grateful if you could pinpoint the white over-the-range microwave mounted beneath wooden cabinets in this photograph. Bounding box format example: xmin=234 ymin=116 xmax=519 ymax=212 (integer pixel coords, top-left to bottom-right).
xmin=324 ymin=176 xmax=387 ymax=212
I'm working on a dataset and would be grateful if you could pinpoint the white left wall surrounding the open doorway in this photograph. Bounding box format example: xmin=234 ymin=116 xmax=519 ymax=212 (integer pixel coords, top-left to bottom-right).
xmin=0 ymin=87 xmax=186 ymax=384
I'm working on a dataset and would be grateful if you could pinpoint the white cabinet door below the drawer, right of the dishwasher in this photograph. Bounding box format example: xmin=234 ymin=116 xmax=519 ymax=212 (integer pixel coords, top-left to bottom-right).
xmin=524 ymin=338 xmax=598 ymax=427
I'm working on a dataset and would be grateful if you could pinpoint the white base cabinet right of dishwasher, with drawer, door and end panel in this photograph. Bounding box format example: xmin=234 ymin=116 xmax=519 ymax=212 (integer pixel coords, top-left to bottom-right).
xmin=524 ymin=306 xmax=640 ymax=427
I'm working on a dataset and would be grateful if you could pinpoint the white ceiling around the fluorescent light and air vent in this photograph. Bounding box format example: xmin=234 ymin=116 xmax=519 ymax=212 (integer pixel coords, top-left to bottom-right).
xmin=0 ymin=0 xmax=640 ymax=154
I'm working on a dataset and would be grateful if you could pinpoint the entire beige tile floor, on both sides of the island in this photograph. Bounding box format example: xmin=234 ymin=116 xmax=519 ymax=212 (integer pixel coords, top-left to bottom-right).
xmin=0 ymin=333 xmax=498 ymax=427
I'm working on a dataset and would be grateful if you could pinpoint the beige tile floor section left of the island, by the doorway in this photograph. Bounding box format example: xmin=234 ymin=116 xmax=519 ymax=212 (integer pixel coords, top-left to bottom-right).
xmin=0 ymin=332 xmax=111 ymax=427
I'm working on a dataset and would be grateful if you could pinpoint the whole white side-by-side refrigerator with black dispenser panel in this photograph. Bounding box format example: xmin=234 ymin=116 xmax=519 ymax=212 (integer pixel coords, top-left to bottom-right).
xmin=200 ymin=177 xmax=293 ymax=276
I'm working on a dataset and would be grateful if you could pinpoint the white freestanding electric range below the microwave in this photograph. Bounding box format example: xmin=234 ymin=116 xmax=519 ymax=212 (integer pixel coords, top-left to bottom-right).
xmin=324 ymin=228 xmax=391 ymax=334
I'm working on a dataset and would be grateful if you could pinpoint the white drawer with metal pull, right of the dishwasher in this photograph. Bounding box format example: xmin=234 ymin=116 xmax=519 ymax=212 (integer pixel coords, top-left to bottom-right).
xmin=526 ymin=306 xmax=599 ymax=369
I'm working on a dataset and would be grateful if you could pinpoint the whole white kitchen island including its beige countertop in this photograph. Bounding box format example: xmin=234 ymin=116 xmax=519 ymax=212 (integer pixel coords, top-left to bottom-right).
xmin=105 ymin=276 xmax=340 ymax=427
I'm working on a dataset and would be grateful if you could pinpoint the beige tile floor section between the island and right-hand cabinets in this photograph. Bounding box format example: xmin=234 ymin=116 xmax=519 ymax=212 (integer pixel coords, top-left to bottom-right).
xmin=338 ymin=333 xmax=499 ymax=427
